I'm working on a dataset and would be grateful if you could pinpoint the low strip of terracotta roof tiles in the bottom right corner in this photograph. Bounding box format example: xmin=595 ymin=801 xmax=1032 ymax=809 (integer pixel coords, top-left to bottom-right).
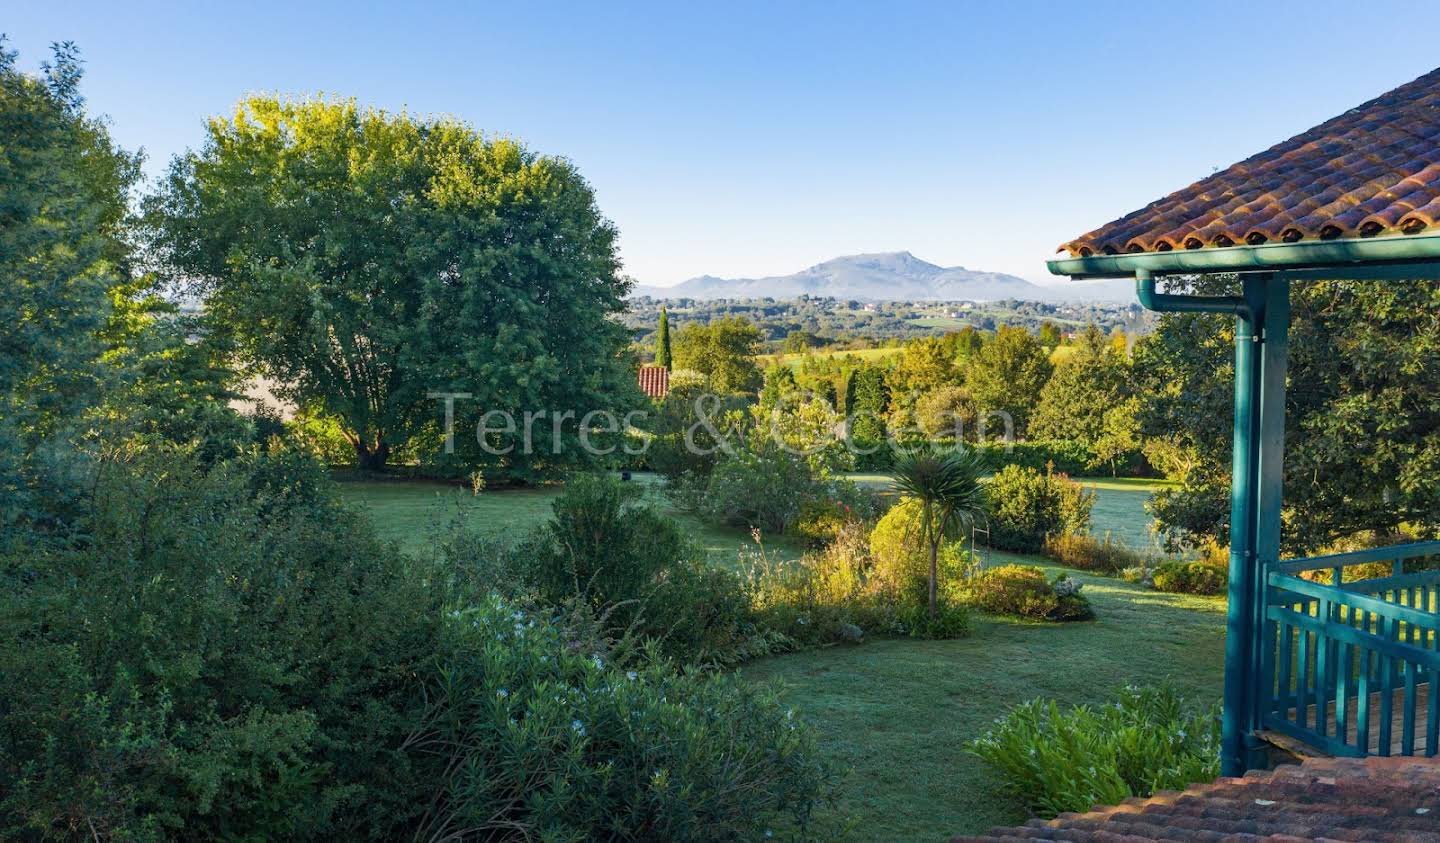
xmin=950 ymin=757 xmax=1440 ymax=843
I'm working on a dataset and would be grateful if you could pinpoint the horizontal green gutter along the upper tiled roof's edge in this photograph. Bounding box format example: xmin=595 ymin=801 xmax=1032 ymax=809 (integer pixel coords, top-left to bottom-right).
xmin=1047 ymin=235 xmax=1440 ymax=278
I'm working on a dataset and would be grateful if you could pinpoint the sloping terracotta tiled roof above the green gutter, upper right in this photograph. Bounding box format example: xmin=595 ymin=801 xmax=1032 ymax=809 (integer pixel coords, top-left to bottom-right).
xmin=1060 ymin=68 xmax=1440 ymax=258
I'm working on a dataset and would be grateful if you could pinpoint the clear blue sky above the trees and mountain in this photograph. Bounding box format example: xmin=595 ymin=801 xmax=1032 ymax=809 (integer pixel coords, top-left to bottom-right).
xmin=11 ymin=0 xmax=1440 ymax=284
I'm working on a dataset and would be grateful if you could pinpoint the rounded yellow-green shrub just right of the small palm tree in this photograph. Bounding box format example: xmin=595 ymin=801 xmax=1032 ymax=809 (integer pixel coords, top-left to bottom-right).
xmin=988 ymin=465 xmax=1094 ymax=553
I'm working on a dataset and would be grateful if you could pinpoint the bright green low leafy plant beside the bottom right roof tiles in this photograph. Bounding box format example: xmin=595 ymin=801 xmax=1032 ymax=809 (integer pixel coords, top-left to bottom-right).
xmin=969 ymin=686 xmax=1220 ymax=816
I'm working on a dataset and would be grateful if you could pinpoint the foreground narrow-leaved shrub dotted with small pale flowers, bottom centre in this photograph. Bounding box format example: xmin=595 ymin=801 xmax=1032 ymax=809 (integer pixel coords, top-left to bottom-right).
xmin=408 ymin=598 xmax=834 ymax=840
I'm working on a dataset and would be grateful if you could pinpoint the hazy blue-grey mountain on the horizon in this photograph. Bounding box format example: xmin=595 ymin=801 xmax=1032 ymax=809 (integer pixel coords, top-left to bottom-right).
xmin=631 ymin=252 xmax=1135 ymax=303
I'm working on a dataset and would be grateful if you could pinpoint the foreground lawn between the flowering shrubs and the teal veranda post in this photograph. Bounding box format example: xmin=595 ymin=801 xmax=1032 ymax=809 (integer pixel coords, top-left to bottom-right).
xmin=743 ymin=553 xmax=1224 ymax=840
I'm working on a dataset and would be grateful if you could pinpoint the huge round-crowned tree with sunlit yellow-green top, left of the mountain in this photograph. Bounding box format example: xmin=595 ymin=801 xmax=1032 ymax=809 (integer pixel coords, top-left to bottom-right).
xmin=147 ymin=97 xmax=634 ymax=468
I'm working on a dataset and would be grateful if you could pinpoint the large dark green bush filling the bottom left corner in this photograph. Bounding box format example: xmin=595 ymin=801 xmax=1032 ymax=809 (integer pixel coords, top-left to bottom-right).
xmin=0 ymin=445 xmax=438 ymax=840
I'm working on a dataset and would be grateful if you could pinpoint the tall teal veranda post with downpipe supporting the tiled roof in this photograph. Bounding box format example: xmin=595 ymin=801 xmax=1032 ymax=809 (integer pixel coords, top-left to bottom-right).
xmin=1220 ymin=272 xmax=1290 ymax=775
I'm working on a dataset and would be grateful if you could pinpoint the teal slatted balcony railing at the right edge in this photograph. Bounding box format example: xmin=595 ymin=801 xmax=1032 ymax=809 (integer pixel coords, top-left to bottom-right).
xmin=1259 ymin=542 xmax=1440 ymax=757
